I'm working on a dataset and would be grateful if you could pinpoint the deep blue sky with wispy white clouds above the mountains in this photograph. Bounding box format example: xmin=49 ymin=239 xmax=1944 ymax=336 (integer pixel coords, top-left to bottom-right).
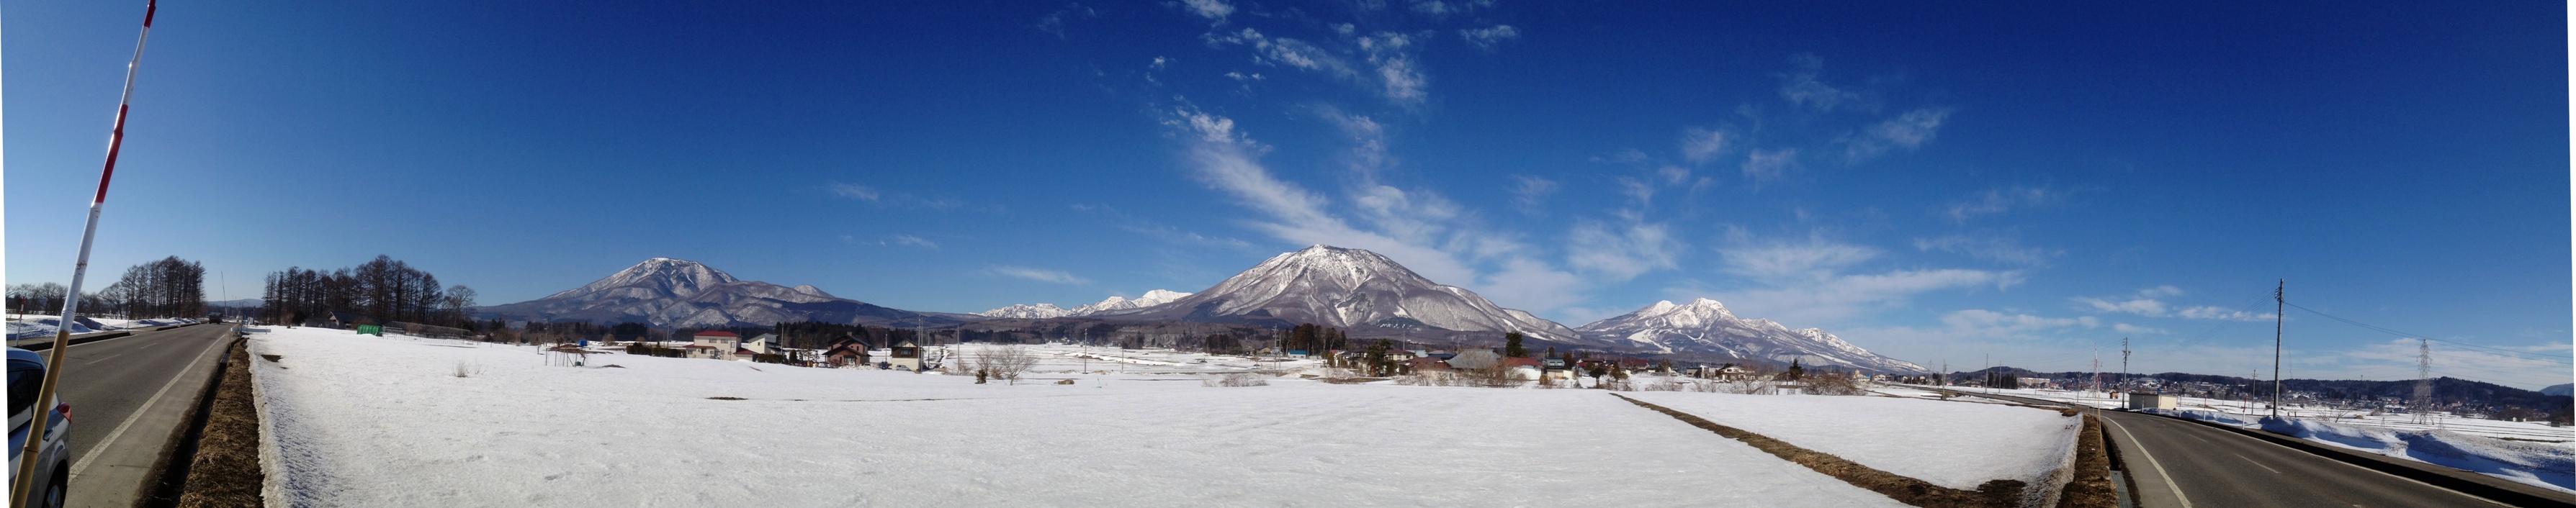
xmin=0 ymin=0 xmax=2571 ymax=387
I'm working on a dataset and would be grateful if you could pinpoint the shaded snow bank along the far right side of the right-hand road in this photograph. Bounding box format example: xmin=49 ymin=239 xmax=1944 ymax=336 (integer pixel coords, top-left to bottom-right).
xmin=2262 ymin=418 xmax=2576 ymax=492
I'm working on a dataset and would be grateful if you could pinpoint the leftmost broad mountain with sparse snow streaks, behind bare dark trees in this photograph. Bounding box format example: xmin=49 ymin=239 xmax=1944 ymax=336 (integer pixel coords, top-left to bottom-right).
xmin=474 ymin=258 xmax=964 ymax=327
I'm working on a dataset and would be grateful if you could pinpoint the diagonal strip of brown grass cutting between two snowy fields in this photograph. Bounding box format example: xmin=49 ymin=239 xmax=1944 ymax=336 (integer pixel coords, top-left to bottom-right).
xmin=1610 ymin=394 xmax=2025 ymax=508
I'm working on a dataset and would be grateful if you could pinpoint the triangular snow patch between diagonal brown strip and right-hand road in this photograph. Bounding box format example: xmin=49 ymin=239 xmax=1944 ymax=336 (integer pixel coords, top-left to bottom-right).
xmin=1623 ymin=392 xmax=2084 ymax=490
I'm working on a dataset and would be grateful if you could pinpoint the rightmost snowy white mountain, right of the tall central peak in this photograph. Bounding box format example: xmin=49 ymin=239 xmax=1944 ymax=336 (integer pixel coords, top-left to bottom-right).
xmin=1574 ymin=299 xmax=1924 ymax=371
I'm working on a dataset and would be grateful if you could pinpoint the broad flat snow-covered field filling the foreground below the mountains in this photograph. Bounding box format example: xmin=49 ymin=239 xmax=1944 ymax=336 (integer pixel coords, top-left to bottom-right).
xmin=250 ymin=327 xmax=2055 ymax=505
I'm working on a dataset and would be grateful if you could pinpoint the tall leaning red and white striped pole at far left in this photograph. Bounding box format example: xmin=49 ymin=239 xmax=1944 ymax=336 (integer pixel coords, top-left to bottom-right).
xmin=10 ymin=0 xmax=160 ymax=505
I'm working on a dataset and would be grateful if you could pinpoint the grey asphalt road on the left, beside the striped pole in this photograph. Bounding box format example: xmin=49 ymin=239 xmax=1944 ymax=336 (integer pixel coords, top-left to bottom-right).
xmin=38 ymin=325 xmax=232 ymax=508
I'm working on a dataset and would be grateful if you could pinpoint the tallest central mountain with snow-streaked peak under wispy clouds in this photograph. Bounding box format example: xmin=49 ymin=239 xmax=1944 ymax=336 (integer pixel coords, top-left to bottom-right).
xmin=1095 ymin=245 xmax=1576 ymax=340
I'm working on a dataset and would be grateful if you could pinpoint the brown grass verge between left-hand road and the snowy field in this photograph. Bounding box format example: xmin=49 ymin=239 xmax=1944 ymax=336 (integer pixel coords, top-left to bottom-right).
xmin=178 ymin=340 xmax=276 ymax=508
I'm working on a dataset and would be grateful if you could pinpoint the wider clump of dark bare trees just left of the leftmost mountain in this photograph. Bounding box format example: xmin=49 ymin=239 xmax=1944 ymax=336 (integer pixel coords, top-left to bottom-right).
xmin=260 ymin=255 xmax=474 ymax=327
